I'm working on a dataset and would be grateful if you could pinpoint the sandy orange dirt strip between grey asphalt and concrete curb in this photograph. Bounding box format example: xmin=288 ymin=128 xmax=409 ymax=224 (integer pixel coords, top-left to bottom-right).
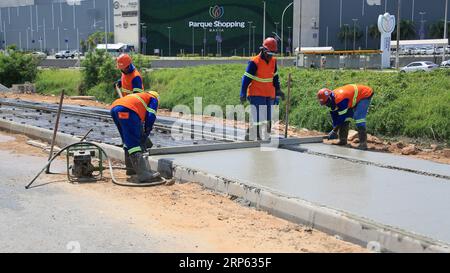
xmin=0 ymin=131 xmax=367 ymax=252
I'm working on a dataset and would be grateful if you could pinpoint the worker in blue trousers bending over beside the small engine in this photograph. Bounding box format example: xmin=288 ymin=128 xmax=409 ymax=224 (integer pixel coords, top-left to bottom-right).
xmin=111 ymin=91 xmax=160 ymax=183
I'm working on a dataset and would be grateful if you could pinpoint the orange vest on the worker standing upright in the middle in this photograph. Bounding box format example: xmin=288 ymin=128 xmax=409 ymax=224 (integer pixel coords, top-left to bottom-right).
xmin=244 ymin=54 xmax=277 ymax=98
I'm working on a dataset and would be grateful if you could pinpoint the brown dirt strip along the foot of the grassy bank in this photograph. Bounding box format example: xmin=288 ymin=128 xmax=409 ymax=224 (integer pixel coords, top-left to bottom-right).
xmin=0 ymin=93 xmax=450 ymax=164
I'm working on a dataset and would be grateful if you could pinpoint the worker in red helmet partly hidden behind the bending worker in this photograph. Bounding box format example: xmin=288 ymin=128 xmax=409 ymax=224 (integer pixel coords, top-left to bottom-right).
xmin=114 ymin=53 xmax=144 ymax=97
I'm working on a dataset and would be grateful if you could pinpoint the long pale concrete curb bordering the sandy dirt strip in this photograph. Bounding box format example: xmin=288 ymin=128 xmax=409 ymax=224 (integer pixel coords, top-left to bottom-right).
xmin=0 ymin=120 xmax=450 ymax=253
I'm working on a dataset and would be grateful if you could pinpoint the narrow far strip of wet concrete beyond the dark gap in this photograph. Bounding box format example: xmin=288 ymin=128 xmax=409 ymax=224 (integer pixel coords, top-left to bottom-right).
xmin=300 ymin=143 xmax=450 ymax=176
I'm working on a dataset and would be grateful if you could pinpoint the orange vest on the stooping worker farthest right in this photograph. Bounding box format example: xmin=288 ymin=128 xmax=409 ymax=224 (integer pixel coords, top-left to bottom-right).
xmin=333 ymin=84 xmax=373 ymax=108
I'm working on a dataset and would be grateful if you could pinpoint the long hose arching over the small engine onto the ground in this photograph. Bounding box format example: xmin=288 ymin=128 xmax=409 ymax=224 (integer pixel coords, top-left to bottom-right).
xmin=25 ymin=141 xmax=167 ymax=189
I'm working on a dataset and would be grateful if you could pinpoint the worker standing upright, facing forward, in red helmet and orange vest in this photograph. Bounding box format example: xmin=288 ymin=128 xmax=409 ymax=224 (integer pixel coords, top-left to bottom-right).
xmin=240 ymin=37 xmax=284 ymax=140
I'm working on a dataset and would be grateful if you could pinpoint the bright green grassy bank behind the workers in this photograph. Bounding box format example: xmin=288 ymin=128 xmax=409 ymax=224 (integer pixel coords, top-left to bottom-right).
xmin=33 ymin=64 xmax=450 ymax=143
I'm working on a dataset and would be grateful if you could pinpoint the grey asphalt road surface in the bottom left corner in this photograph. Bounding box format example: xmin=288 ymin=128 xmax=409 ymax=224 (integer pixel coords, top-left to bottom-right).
xmin=0 ymin=143 xmax=189 ymax=252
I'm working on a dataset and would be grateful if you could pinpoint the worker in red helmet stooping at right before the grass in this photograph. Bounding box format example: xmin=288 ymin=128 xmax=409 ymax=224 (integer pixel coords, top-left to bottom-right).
xmin=317 ymin=84 xmax=374 ymax=150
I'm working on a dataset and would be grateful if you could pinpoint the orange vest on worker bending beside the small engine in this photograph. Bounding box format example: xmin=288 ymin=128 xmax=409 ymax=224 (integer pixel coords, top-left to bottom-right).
xmin=111 ymin=92 xmax=159 ymax=121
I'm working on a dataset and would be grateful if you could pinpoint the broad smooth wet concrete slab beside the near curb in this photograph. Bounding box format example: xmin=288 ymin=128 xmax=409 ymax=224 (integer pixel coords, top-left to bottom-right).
xmin=155 ymin=148 xmax=450 ymax=243
